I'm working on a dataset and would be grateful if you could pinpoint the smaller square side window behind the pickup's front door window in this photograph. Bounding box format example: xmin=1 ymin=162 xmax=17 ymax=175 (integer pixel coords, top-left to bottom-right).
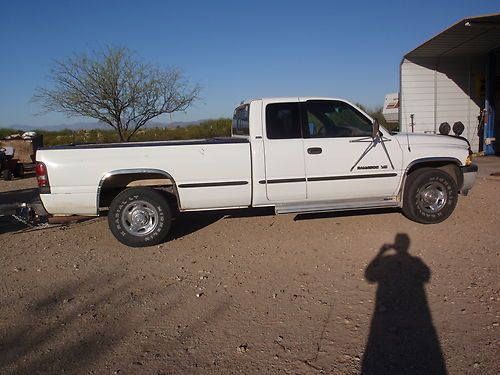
xmin=266 ymin=103 xmax=302 ymax=139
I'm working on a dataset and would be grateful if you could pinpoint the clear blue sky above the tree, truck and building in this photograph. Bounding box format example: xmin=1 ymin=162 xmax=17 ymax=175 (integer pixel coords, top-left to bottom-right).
xmin=0 ymin=0 xmax=500 ymax=127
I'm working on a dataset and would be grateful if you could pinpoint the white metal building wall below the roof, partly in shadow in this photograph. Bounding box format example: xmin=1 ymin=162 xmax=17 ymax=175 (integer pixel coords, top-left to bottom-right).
xmin=400 ymin=57 xmax=484 ymax=151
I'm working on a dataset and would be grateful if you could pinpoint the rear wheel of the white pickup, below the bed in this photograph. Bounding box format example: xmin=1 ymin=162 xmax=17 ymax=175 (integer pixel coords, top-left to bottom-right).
xmin=108 ymin=188 xmax=172 ymax=247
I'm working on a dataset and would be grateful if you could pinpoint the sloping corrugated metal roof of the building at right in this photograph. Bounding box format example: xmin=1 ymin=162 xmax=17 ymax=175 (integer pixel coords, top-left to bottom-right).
xmin=405 ymin=13 xmax=500 ymax=59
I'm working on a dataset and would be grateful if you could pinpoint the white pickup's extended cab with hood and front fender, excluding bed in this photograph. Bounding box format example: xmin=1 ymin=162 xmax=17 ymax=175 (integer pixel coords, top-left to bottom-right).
xmin=240 ymin=97 xmax=469 ymax=213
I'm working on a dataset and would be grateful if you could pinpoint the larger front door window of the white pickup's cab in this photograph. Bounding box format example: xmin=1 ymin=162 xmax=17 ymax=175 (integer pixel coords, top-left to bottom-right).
xmin=305 ymin=100 xmax=372 ymax=138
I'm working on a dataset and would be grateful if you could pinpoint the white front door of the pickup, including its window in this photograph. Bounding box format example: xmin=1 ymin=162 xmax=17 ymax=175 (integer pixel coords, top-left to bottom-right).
xmin=301 ymin=100 xmax=402 ymax=201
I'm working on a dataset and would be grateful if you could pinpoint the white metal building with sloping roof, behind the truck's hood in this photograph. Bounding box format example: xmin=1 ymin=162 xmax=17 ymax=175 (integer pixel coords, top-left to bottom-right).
xmin=399 ymin=13 xmax=500 ymax=154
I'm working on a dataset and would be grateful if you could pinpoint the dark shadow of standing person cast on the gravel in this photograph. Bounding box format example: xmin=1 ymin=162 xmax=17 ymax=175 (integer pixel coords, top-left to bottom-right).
xmin=361 ymin=233 xmax=447 ymax=375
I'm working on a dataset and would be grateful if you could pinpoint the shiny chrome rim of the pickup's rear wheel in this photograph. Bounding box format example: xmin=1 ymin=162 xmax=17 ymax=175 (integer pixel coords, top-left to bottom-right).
xmin=121 ymin=200 xmax=158 ymax=236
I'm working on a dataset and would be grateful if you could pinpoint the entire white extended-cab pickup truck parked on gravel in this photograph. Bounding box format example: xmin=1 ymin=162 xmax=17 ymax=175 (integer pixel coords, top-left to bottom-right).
xmin=36 ymin=97 xmax=477 ymax=247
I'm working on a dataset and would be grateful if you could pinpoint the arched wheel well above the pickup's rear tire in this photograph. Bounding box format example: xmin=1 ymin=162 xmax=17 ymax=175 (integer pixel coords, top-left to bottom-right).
xmin=97 ymin=172 xmax=180 ymax=211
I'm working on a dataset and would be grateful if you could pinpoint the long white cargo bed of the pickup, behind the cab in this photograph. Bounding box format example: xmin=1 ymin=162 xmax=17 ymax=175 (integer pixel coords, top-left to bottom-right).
xmin=37 ymin=138 xmax=252 ymax=215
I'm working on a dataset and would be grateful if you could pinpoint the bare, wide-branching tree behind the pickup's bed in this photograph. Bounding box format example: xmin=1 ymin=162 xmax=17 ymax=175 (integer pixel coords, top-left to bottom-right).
xmin=33 ymin=47 xmax=200 ymax=141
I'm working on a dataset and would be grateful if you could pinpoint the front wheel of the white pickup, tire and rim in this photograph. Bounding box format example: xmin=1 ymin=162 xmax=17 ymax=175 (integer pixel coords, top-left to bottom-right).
xmin=403 ymin=168 xmax=458 ymax=224
